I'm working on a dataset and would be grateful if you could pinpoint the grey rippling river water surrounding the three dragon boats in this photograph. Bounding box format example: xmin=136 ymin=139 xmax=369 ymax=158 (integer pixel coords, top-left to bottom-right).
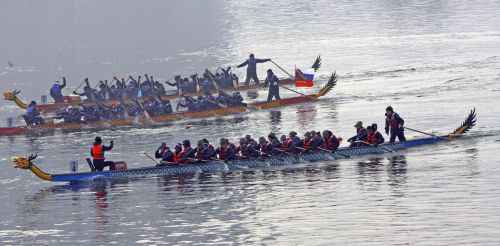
xmin=0 ymin=0 xmax=500 ymax=245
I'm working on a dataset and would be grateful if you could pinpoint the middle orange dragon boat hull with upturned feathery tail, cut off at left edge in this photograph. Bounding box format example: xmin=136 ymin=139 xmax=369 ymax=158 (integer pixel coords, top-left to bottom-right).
xmin=0 ymin=73 xmax=337 ymax=136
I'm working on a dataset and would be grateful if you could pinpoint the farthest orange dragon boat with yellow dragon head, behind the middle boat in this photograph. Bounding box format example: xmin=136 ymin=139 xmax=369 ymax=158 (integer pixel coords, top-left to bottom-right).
xmin=3 ymin=78 xmax=294 ymax=112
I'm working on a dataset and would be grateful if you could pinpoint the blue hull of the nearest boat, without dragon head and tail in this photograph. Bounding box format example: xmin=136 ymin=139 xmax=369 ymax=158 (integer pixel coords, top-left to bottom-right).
xmin=52 ymin=138 xmax=444 ymax=182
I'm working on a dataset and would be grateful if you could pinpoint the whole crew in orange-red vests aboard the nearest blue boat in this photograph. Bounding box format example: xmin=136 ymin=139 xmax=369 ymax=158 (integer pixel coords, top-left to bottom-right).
xmin=91 ymin=106 xmax=406 ymax=171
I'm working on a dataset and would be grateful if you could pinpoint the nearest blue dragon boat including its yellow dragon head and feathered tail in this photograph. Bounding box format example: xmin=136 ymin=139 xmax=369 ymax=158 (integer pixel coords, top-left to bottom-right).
xmin=12 ymin=110 xmax=476 ymax=182
